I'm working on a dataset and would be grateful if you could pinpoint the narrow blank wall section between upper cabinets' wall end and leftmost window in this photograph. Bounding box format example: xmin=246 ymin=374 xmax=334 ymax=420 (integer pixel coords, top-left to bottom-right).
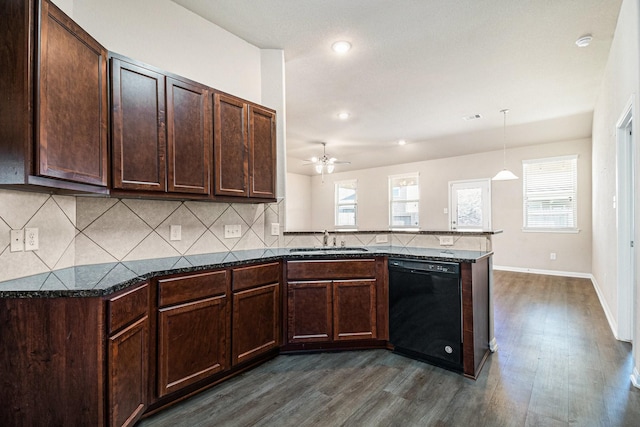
xmin=285 ymin=173 xmax=312 ymax=231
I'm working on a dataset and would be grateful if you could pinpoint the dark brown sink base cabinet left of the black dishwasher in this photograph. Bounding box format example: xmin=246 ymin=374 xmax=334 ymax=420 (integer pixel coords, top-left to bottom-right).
xmin=285 ymin=257 xmax=388 ymax=351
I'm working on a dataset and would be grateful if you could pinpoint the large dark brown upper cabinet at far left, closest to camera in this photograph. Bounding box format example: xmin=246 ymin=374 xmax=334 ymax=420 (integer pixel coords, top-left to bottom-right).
xmin=0 ymin=0 xmax=108 ymax=193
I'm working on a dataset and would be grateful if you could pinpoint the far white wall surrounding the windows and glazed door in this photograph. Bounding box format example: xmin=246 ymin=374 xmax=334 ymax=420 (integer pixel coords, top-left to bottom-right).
xmin=287 ymin=139 xmax=591 ymax=274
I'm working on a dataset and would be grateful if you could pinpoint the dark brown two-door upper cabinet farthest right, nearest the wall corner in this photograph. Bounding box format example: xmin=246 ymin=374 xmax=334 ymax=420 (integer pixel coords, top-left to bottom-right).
xmin=213 ymin=93 xmax=276 ymax=199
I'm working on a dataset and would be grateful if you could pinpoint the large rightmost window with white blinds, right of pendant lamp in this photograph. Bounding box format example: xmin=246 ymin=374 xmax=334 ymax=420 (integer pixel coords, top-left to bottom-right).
xmin=522 ymin=155 xmax=578 ymax=232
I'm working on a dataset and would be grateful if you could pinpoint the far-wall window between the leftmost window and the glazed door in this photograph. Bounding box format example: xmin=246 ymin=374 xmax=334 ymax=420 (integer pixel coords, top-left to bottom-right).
xmin=389 ymin=173 xmax=420 ymax=228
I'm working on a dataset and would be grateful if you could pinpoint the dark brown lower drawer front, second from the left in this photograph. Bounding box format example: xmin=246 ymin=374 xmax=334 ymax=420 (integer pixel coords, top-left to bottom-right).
xmin=158 ymin=270 xmax=227 ymax=307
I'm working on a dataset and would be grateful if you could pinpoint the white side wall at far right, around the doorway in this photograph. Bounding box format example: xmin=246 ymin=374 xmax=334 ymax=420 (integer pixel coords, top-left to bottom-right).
xmin=592 ymin=0 xmax=640 ymax=382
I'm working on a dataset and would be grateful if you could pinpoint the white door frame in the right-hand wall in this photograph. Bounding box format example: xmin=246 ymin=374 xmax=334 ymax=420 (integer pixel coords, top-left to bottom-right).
xmin=616 ymin=97 xmax=637 ymax=341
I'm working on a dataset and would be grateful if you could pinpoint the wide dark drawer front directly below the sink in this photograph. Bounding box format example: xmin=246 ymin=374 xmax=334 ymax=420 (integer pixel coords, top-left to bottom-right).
xmin=287 ymin=259 xmax=376 ymax=280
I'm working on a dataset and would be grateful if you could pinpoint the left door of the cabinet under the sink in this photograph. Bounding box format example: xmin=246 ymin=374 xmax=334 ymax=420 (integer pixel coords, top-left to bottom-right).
xmin=287 ymin=281 xmax=333 ymax=343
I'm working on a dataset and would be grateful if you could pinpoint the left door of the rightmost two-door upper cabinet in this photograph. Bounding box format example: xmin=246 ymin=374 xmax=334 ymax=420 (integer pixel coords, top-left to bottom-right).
xmin=213 ymin=93 xmax=249 ymax=197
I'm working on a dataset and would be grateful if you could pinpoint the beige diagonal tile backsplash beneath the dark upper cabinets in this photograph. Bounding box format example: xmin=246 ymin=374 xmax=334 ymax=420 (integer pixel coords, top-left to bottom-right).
xmin=0 ymin=190 xmax=283 ymax=281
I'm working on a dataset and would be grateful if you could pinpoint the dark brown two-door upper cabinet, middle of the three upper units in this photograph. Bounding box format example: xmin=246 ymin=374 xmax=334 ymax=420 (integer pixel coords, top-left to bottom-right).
xmin=111 ymin=55 xmax=212 ymax=195
